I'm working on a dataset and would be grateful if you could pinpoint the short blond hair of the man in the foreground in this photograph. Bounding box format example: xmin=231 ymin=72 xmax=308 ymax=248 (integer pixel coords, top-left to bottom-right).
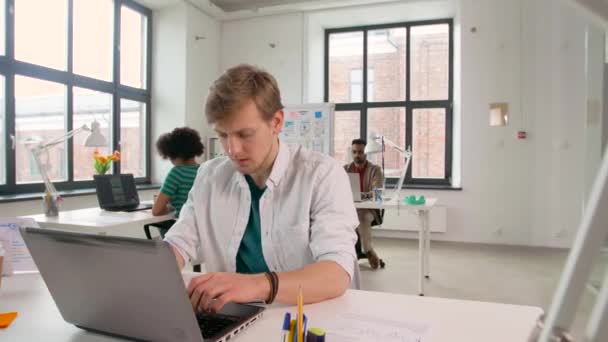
xmin=205 ymin=64 xmax=283 ymax=123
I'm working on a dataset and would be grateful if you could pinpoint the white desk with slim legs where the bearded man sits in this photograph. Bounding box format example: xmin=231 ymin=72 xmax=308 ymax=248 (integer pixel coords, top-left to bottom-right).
xmin=355 ymin=198 xmax=437 ymax=296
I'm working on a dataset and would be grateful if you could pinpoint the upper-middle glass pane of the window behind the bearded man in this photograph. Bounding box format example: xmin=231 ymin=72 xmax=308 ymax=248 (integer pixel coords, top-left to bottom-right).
xmin=367 ymin=27 xmax=407 ymax=102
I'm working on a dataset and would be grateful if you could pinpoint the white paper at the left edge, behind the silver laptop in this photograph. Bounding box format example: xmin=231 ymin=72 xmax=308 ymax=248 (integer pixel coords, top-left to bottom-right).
xmin=0 ymin=217 xmax=39 ymax=275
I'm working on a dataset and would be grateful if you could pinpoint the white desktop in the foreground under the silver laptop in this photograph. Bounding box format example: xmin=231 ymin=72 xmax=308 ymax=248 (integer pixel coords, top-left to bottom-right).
xmin=0 ymin=274 xmax=542 ymax=342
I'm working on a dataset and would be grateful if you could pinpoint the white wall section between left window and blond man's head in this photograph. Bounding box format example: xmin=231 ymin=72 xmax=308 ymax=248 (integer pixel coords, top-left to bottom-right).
xmin=151 ymin=2 xmax=220 ymax=183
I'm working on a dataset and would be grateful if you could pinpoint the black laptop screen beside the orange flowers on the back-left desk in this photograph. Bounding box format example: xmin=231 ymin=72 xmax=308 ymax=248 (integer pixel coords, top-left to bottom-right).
xmin=94 ymin=173 xmax=139 ymax=209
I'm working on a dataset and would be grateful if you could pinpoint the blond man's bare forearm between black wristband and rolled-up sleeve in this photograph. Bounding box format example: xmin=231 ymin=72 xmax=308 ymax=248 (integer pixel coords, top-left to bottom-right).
xmin=275 ymin=261 xmax=350 ymax=304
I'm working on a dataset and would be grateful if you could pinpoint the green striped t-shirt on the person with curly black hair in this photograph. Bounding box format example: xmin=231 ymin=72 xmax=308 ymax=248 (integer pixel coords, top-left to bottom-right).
xmin=160 ymin=165 xmax=200 ymax=216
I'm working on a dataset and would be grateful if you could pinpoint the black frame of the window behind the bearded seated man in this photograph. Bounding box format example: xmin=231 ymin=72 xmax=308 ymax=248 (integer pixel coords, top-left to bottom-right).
xmin=324 ymin=18 xmax=454 ymax=188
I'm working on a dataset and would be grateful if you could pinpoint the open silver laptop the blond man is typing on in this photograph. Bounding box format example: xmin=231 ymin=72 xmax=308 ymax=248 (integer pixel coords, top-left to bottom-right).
xmin=21 ymin=228 xmax=264 ymax=342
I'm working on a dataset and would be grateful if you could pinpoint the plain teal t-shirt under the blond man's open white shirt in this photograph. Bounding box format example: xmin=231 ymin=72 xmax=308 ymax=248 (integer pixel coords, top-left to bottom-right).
xmin=236 ymin=175 xmax=269 ymax=274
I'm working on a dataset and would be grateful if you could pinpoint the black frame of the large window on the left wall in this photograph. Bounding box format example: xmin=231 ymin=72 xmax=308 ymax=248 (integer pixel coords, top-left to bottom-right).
xmin=0 ymin=0 xmax=153 ymax=196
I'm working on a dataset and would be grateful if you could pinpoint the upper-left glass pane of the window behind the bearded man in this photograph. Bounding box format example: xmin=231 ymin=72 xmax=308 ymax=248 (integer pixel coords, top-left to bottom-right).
xmin=329 ymin=32 xmax=363 ymax=103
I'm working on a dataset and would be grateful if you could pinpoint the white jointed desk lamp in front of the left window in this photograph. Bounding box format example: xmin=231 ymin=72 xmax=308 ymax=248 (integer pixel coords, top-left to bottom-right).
xmin=23 ymin=121 xmax=108 ymax=216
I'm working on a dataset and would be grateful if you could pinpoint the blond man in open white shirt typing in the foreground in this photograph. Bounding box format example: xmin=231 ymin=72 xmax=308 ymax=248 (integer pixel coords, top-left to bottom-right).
xmin=165 ymin=65 xmax=357 ymax=311
